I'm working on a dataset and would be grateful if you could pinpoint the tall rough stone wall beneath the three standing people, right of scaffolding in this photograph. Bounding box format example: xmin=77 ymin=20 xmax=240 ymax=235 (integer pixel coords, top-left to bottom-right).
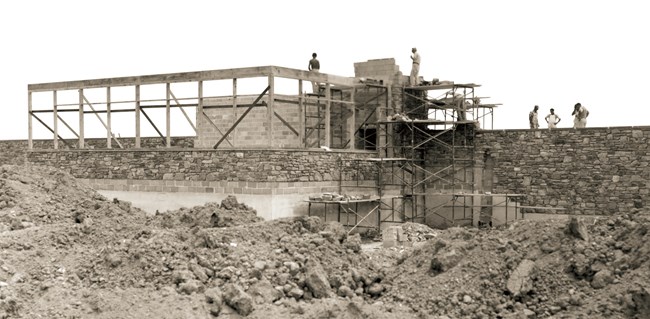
xmin=476 ymin=127 xmax=650 ymax=215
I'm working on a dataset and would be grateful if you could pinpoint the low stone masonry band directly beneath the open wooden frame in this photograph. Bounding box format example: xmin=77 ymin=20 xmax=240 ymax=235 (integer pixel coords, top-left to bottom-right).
xmin=27 ymin=149 xmax=375 ymax=182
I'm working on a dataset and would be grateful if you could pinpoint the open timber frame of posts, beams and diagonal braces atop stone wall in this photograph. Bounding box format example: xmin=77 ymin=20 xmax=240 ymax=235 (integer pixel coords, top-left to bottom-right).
xmin=28 ymin=66 xmax=365 ymax=149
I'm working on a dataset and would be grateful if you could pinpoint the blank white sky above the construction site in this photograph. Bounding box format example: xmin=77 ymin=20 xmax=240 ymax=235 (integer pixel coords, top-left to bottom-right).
xmin=0 ymin=0 xmax=650 ymax=139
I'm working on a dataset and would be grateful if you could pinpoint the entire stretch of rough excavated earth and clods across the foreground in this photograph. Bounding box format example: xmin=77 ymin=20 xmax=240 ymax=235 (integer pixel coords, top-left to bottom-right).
xmin=0 ymin=165 xmax=650 ymax=319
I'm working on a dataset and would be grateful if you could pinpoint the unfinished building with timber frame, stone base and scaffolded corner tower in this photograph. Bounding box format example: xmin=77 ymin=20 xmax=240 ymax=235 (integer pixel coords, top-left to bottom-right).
xmin=28 ymin=59 xmax=523 ymax=229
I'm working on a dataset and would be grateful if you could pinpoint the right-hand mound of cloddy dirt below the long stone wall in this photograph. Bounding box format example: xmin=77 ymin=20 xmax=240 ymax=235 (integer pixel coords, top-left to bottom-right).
xmin=381 ymin=211 xmax=650 ymax=318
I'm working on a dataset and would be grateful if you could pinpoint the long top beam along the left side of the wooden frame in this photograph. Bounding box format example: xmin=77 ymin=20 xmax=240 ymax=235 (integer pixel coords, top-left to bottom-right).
xmin=27 ymin=66 xmax=272 ymax=92
